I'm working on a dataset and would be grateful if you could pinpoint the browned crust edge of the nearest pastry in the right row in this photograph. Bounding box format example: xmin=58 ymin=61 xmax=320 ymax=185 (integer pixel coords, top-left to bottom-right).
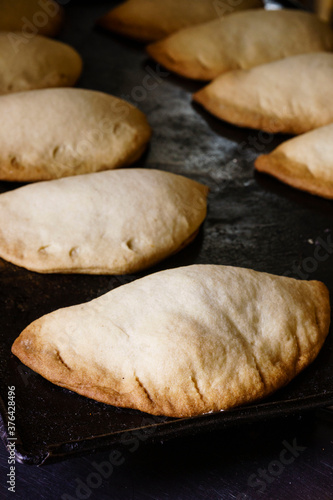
xmin=254 ymin=151 xmax=333 ymax=199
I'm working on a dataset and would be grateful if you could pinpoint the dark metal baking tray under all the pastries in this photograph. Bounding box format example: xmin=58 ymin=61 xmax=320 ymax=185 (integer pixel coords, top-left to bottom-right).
xmin=0 ymin=1 xmax=333 ymax=464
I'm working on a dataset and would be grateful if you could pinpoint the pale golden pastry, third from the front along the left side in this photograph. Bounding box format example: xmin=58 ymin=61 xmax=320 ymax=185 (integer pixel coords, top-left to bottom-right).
xmin=0 ymin=88 xmax=151 ymax=182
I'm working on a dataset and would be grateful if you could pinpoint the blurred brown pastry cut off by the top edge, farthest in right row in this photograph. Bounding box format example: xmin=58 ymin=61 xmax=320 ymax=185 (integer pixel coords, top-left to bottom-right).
xmin=98 ymin=0 xmax=263 ymax=42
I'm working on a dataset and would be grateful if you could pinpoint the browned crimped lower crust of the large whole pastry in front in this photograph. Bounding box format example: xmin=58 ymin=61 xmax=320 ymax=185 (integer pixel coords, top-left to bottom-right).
xmin=12 ymin=281 xmax=330 ymax=418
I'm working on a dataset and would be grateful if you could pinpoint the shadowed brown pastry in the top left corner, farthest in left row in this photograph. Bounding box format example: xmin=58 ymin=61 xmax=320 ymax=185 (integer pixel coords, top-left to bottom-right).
xmin=0 ymin=0 xmax=64 ymax=36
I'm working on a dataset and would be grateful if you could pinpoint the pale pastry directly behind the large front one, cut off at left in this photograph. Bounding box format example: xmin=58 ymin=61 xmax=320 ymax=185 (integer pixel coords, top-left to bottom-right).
xmin=0 ymin=169 xmax=208 ymax=274
